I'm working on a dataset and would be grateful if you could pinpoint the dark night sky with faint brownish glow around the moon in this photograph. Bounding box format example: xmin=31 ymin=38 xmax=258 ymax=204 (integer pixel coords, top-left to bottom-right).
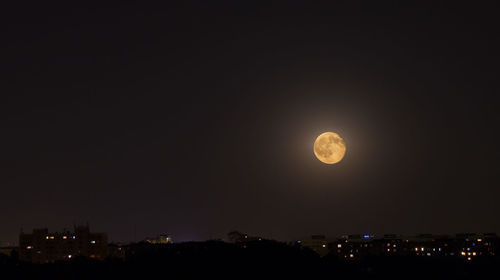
xmin=0 ymin=1 xmax=500 ymax=244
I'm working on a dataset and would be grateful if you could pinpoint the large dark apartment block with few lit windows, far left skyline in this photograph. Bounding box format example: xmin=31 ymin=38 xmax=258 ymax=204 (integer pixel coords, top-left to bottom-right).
xmin=19 ymin=226 xmax=108 ymax=263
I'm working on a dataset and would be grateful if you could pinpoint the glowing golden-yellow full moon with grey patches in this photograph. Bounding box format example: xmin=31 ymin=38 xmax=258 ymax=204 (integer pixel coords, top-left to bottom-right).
xmin=314 ymin=132 xmax=346 ymax=164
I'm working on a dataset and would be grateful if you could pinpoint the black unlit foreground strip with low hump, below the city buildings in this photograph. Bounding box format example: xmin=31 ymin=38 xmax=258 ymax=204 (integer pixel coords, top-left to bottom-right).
xmin=0 ymin=241 xmax=500 ymax=279
